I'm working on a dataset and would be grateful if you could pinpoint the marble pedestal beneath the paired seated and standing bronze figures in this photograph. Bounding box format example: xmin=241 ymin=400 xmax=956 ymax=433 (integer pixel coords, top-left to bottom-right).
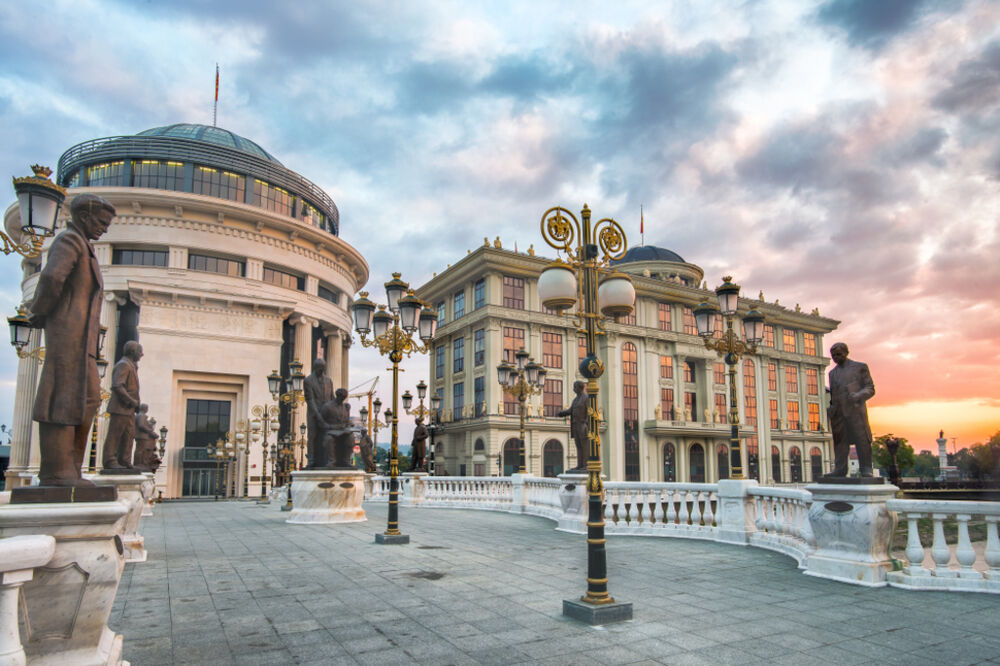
xmin=285 ymin=469 xmax=368 ymax=525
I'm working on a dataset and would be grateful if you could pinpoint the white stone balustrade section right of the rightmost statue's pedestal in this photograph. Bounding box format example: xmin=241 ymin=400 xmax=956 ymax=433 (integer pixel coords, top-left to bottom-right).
xmin=886 ymin=499 xmax=1000 ymax=593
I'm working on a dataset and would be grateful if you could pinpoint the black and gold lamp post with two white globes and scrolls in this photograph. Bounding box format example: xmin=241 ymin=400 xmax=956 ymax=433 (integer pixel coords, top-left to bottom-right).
xmin=538 ymin=204 xmax=635 ymax=625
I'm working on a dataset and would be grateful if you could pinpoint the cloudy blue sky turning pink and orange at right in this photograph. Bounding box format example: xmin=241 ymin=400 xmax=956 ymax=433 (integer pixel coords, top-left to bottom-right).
xmin=0 ymin=0 xmax=1000 ymax=451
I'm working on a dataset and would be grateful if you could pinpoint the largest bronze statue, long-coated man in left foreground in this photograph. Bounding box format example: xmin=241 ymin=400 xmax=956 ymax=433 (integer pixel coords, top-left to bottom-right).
xmin=29 ymin=194 xmax=115 ymax=486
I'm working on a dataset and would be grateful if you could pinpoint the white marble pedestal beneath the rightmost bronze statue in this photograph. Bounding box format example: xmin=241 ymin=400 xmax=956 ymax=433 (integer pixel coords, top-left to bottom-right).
xmin=803 ymin=483 xmax=898 ymax=587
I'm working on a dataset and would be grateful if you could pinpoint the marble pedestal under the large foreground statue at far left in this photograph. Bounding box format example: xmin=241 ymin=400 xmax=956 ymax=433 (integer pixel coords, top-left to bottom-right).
xmin=0 ymin=502 xmax=128 ymax=666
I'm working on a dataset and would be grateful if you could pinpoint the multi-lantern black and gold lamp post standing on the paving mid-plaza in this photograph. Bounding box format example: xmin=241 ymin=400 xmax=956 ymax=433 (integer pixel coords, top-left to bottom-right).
xmin=353 ymin=273 xmax=437 ymax=544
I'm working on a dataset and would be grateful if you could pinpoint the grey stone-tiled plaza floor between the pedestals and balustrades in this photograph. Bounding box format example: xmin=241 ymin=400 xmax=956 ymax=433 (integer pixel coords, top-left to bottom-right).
xmin=110 ymin=501 xmax=1000 ymax=666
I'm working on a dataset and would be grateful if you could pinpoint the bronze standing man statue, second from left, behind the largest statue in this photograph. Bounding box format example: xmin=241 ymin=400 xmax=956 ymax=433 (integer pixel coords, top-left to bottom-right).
xmin=102 ymin=340 xmax=142 ymax=474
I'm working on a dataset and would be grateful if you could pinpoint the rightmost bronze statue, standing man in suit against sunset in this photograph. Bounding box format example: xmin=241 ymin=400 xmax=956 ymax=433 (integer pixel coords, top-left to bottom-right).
xmin=827 ymin=342 xmax=875 ymax=477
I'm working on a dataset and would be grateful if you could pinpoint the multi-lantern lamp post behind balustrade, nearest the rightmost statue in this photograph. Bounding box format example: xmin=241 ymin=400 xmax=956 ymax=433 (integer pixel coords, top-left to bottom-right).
xmin=694 ymin=275 xmax=764 ymax=479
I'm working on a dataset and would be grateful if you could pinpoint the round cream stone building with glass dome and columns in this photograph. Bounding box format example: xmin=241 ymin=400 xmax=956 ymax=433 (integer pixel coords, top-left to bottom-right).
xmin=4 ymin=124 xmax=368 ymax=497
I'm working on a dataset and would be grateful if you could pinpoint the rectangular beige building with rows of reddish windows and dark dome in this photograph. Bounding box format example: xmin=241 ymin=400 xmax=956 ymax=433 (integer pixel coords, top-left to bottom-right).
xmin=417 ymin=241 xmax=839 ymax=483
